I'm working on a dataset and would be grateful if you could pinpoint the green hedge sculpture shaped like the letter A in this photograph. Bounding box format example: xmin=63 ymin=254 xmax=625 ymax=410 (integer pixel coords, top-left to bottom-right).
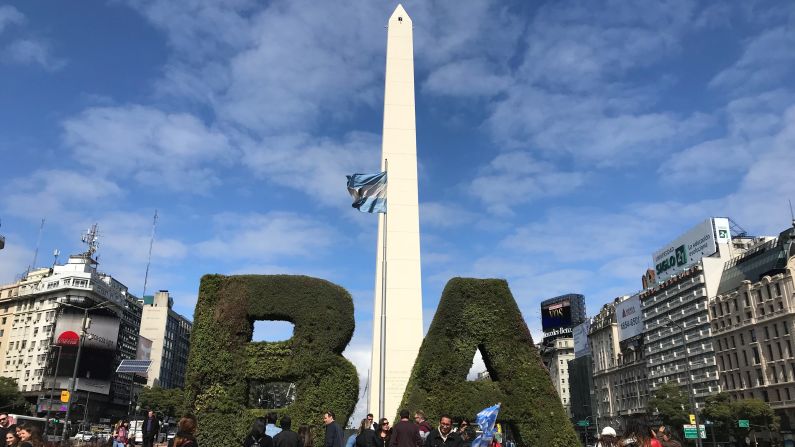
xmin=400 ymin=278 xmax=580 ymax=447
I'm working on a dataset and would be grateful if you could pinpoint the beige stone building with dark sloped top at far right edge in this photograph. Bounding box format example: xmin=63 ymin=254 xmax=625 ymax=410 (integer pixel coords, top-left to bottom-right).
xmin=709 ymin=228 xmax=795 ymax=429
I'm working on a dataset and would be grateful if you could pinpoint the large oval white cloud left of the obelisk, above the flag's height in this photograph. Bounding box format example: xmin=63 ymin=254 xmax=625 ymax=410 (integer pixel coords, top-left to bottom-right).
xmin=63 ymin=105 xmax=237 ymax=193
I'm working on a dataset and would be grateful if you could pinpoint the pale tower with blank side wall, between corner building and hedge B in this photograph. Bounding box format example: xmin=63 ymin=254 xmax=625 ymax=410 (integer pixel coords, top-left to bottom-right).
xmin=140 ymin=290 xmax=193 ymax=388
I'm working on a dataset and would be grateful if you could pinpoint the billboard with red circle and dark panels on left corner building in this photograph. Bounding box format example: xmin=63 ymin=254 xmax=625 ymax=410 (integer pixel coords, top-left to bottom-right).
xmin=48 ymin=310 xmax=121 ymax=394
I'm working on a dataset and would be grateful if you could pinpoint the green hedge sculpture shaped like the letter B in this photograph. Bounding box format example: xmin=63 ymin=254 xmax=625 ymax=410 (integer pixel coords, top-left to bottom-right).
xmin=185 ymin=275 xmax=359 ymax=447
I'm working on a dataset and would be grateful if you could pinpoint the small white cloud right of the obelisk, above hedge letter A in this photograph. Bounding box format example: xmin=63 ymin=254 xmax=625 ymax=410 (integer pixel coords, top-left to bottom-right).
xmin=469 ymin=152 xmax=585 ymax=214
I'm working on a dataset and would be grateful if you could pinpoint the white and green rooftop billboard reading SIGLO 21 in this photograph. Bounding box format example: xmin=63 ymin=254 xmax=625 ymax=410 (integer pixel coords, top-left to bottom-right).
xmin=653 ymin=217 xmax=731 ymax=284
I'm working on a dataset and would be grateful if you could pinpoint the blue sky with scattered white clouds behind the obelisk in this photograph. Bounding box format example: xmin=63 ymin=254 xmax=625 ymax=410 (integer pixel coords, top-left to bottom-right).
xmin=0 ymin=0 xmax=795 ymax=424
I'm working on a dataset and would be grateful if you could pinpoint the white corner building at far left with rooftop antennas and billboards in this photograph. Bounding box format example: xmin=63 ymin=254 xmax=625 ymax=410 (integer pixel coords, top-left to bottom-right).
xmin=0 ymin=251 xmax=141 ymax=420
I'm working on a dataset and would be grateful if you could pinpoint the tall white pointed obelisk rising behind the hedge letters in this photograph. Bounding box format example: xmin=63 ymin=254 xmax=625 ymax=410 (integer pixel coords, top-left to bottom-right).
xmin=369 ymin=5 xmax=422 ymax=420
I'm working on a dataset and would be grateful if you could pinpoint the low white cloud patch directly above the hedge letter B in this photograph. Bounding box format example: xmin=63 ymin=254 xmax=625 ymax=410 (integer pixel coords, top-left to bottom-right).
xmin=196 ymin=212 xmax=335 ymax=263
